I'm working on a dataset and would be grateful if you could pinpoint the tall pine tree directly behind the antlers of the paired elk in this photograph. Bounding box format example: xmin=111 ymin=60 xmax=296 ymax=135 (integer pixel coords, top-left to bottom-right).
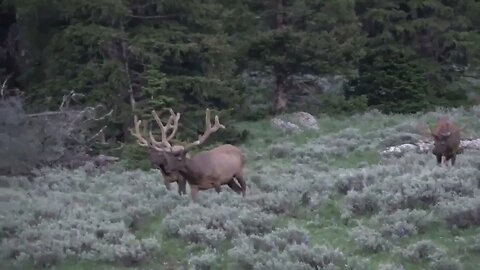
xmin=130 ymin=0 xmax=246 ymax=141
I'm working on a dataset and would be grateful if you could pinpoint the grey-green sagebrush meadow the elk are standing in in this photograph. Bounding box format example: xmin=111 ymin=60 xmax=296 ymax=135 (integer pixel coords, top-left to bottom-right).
xmin=0 ymin=107 xmax=480 ymax=270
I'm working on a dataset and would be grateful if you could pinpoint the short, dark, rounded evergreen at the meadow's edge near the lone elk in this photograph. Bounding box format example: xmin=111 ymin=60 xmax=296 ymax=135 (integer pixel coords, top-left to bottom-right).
xmin=345 ymin=49 xmax=431 ymax=113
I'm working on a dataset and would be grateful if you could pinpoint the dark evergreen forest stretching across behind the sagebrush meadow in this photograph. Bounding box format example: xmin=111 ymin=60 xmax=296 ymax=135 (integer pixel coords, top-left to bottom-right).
xmin=0 ymin=0 xmax=480 ymax=146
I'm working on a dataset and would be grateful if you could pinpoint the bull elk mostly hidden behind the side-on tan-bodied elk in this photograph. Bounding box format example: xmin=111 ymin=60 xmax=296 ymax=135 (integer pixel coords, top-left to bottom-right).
xmin=130 ymin=110 xmax=187 ymax=195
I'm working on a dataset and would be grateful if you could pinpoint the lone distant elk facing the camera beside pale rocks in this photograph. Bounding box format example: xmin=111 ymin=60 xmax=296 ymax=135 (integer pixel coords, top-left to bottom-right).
xmin=427 ymin=117 xmax=466 ymax=166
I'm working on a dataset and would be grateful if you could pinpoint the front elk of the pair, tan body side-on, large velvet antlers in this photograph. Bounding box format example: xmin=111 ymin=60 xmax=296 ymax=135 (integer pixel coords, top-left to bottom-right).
xmin=131 ymin=109 xmax=246 ymax=202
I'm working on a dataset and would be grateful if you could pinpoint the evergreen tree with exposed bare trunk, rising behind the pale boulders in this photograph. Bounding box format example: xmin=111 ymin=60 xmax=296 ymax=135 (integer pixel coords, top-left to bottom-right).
xmin=244 ymin=0 xmax=362 ymax=110
